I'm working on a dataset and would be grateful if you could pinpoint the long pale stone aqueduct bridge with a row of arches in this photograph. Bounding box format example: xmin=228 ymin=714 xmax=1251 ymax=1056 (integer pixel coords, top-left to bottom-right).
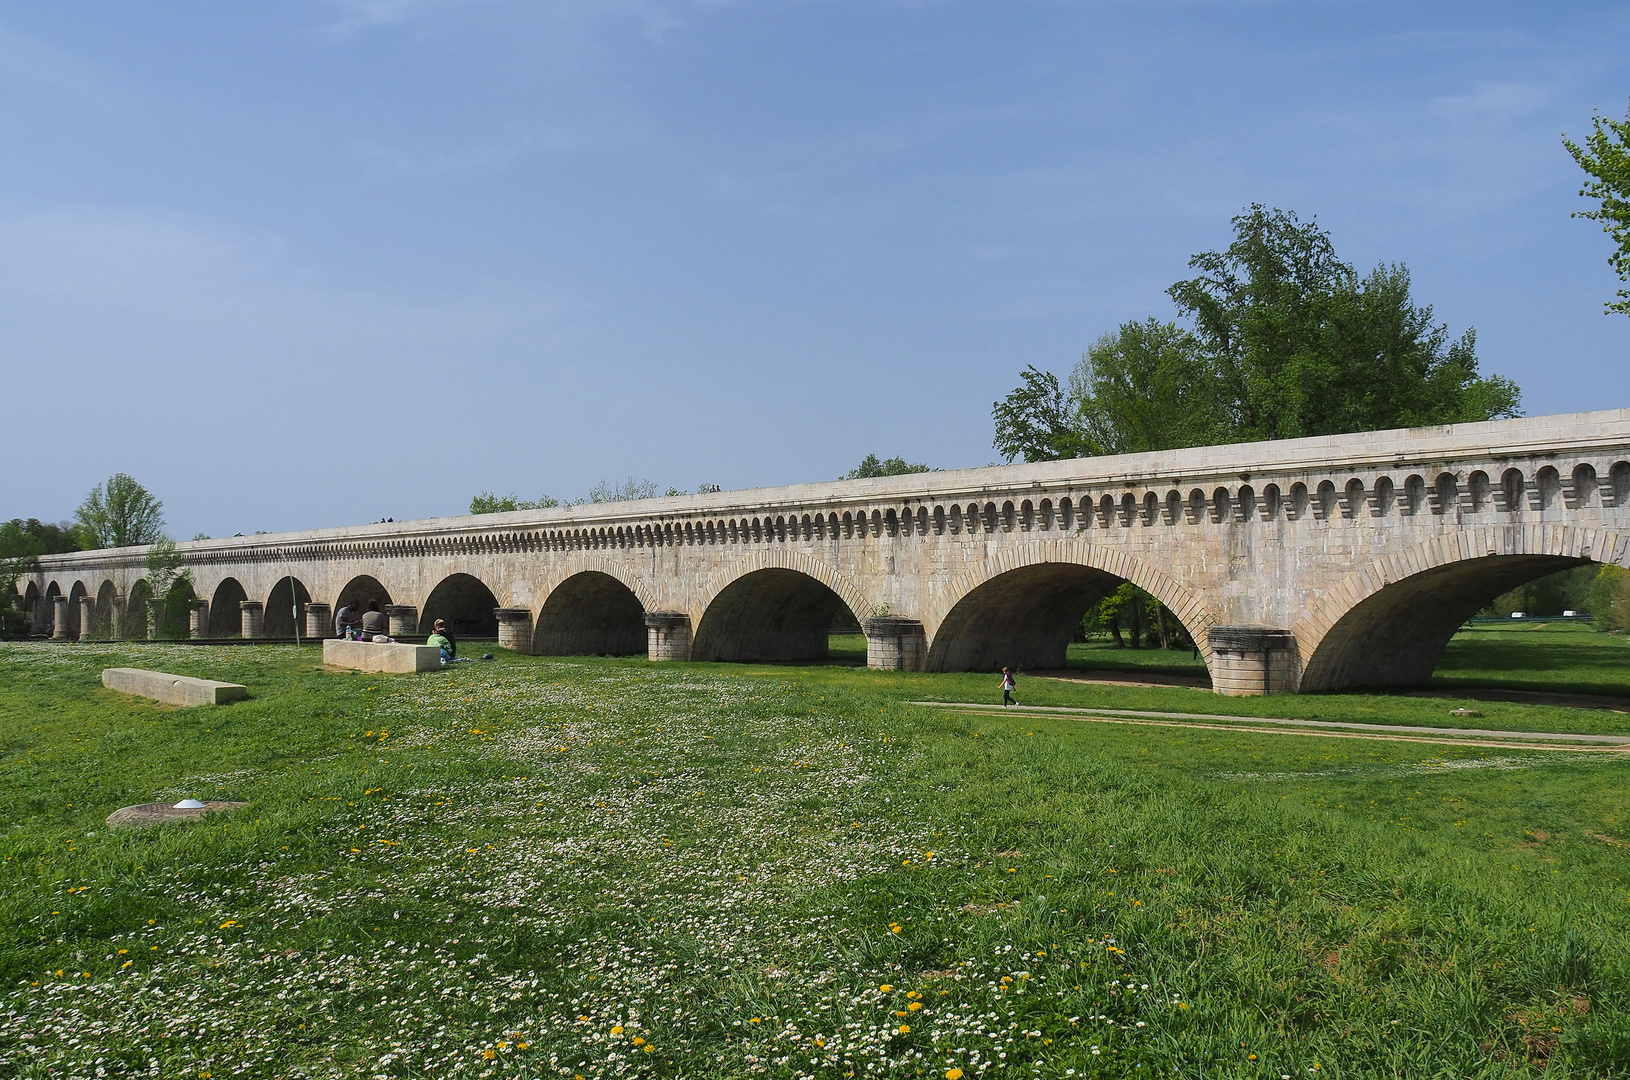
xmin=20 ymin=409 xmax=1630 ymax=694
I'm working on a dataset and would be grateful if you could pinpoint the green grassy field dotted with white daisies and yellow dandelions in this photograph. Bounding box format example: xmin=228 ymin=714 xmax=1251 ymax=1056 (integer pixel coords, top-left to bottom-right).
xmin=0 ymin=645 xmax=1630 ymax=1080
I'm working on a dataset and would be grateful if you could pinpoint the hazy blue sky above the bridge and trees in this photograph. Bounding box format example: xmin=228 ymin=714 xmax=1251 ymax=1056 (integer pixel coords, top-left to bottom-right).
xmin=0 ymin=0 xmax=1630 ymax=538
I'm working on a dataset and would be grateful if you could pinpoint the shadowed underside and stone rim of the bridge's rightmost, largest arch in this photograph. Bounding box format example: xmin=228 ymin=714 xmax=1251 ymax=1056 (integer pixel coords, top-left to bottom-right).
xmin=1293 ymin=526 xmax=1630 ymax=692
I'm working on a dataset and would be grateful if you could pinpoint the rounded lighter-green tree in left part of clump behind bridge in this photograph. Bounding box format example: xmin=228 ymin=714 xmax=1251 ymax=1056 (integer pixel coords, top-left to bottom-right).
xmin=1069 ymin=319 xmax=1227 ymax=454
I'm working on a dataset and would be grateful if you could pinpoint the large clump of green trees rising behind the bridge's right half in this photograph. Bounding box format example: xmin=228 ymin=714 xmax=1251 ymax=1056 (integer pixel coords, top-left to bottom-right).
xmin=993 ymin=205 xmax=1521 ymax=461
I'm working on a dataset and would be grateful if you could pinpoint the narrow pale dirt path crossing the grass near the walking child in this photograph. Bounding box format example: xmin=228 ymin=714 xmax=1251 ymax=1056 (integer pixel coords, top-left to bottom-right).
xmin=911 ymin=700 xmax=1630 ymax=753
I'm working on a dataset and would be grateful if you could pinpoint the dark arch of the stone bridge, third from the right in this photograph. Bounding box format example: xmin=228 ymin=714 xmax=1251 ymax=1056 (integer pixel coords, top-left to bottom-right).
xmin=691 ymin=559 xmax=870 ymax=663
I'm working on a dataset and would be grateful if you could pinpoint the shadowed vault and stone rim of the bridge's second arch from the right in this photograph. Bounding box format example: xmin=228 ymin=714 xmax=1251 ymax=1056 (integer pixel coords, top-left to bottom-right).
xmin=927 ymin=541 xmax=1216 ymax=671
